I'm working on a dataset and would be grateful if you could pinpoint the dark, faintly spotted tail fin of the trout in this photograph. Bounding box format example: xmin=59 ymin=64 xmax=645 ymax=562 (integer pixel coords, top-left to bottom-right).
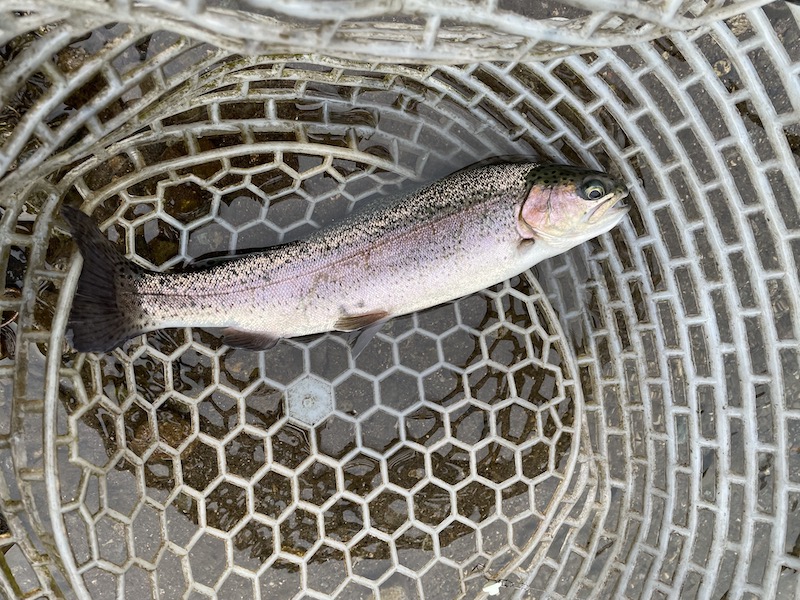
xmin=61 ymin=206 xmax=145 ymax=352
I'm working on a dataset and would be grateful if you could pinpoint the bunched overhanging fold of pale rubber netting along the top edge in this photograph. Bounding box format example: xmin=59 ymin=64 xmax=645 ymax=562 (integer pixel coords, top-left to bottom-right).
xmin=0 ymin=0 xmax=767 ymax=63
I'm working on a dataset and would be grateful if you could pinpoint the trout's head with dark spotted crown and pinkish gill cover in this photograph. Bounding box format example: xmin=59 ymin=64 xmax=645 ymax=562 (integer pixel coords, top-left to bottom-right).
xmin=517 ymin=165 xmax=629 ymax=249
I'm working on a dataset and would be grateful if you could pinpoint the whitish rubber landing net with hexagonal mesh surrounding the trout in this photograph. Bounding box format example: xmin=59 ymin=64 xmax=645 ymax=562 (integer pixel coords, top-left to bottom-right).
xmin=0 ymin=0 xmax=800 ymax=599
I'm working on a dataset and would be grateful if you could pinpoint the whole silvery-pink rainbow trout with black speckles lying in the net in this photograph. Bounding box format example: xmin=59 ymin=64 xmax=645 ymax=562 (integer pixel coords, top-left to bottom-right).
xmin=61 ymin=161 xmax=629 ymax=353
